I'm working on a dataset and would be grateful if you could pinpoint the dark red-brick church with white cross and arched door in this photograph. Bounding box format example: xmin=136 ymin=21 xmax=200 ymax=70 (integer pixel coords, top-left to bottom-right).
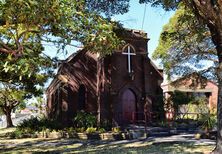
xmin=46 ymin=30 xmax=163 ymax=126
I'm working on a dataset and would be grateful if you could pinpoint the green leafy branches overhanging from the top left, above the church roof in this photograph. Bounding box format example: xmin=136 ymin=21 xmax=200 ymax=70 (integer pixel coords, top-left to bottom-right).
xmin=0 ymin=0 xmax=129 ymax=57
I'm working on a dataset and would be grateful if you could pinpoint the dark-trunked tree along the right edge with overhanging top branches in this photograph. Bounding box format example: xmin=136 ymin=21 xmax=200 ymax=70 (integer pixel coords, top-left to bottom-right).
xmin=140 ymin=0 xmax=222 ymax=153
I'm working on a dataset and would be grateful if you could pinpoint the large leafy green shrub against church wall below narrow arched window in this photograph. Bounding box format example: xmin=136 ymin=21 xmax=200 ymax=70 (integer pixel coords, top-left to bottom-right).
xmin=73 ymin=112 xmax=96 ymax=129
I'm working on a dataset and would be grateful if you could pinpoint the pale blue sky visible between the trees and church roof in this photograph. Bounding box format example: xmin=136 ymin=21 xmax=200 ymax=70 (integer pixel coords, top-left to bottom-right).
xmin=45 ymin=0 xmax=174 ymax=65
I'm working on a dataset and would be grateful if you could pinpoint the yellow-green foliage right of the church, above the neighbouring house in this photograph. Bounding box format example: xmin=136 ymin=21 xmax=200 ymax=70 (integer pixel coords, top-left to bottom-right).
xmin=153 ymin=6 xmax=218 ymax=80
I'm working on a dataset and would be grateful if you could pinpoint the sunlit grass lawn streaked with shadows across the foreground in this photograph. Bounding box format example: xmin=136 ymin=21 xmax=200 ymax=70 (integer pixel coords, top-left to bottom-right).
xmin=0 ymin=129 xmax=214 ymax=154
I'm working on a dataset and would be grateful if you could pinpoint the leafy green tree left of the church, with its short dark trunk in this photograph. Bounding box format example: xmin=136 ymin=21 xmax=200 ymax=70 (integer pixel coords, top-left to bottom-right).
xmin=0 ymin=25 xmax=53 ymax=127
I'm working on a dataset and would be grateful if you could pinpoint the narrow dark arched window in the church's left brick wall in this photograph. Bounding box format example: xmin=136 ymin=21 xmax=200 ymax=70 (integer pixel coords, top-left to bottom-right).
xmin=77 ymin=85 xmax=86 ymax=110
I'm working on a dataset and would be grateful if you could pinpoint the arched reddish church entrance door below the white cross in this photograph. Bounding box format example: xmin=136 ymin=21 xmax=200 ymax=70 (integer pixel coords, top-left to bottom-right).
xmin=122 ymin=89 xmax=136 ymax=123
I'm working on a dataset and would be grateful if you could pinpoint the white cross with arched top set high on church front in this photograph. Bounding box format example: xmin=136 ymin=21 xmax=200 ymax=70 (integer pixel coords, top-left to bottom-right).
xmin=122 ymin=44 xmax=136 ymax=73
